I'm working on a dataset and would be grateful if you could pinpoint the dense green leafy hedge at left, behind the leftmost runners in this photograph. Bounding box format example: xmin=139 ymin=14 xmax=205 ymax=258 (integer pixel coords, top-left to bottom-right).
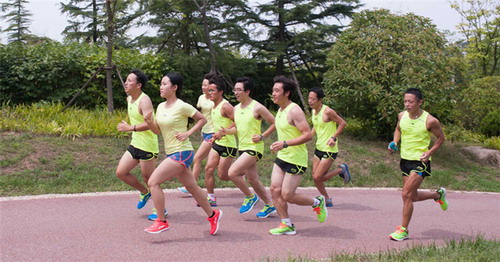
xmin=0 ymin=42 xmax=172 ymax=108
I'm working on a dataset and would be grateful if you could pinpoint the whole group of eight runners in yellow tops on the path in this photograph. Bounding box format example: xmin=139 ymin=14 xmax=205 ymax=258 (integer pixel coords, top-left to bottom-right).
xmin=116 ymin=70 xmax=448 ymax=240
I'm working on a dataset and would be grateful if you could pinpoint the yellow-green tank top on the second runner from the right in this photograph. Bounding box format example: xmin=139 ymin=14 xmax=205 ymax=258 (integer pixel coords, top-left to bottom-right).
xmin=312 ymin=105 xmax=339 ymax=153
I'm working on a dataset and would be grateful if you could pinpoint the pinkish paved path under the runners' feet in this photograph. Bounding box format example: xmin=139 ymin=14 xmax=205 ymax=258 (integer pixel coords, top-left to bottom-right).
xmin=0 ymin=188 xmax=500 ymax=262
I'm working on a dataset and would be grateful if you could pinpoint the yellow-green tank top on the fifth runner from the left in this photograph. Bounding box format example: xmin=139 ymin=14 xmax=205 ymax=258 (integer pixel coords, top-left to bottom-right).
xmin=234 ymin=100 xmax=264 ymax=154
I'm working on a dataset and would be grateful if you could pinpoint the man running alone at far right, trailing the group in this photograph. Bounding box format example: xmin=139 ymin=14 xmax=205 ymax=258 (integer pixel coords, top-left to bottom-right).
xmin=388 ymin=88 xmax=448 ymax=241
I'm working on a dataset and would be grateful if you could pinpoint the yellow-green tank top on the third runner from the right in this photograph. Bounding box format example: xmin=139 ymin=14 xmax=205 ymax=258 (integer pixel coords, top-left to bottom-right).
xmin=275 ymin=103 xmax=307 ymax=167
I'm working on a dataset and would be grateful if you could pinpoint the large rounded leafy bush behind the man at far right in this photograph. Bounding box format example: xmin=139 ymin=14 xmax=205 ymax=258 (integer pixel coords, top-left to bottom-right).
xmin=324 ymin=9 xmax=459 ymax=137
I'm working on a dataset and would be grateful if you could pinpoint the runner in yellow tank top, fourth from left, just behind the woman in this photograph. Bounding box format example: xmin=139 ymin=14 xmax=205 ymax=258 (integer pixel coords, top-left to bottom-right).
xmin=205 ymin=75 xmax=237 ymax=206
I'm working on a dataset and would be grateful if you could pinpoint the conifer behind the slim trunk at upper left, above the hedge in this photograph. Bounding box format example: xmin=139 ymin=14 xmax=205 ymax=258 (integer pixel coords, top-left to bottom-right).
xmin=60 ymin=0 xmax=144 ymax=46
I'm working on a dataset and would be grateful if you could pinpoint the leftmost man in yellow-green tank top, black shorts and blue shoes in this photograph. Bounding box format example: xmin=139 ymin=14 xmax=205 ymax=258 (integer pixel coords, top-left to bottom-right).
xmin=116 ymin=70 xmax=158 ymax=217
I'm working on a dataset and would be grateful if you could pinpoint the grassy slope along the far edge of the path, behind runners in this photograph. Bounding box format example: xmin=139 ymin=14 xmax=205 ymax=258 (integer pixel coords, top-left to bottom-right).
xmin=0 ymin=132 xmax=500 ymax=196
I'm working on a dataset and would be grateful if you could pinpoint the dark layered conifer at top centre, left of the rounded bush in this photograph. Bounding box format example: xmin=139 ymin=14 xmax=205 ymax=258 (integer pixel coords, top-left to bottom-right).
xmin=251 ymin=0 xmax=360 ymax=74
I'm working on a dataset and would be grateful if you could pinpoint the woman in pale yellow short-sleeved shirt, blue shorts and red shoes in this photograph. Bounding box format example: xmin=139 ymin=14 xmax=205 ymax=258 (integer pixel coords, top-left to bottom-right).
xmin=144 ymin=73 xmax=222 ymax=235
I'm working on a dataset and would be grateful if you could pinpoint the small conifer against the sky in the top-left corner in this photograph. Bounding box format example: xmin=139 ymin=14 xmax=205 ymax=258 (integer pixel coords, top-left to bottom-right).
xmin=0 ymin=0 xmax=32 ymax=43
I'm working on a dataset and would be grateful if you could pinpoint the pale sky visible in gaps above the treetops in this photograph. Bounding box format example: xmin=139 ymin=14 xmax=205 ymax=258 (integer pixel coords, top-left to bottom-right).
xmin=0 ymin=0 xmax=461 ymax=43
